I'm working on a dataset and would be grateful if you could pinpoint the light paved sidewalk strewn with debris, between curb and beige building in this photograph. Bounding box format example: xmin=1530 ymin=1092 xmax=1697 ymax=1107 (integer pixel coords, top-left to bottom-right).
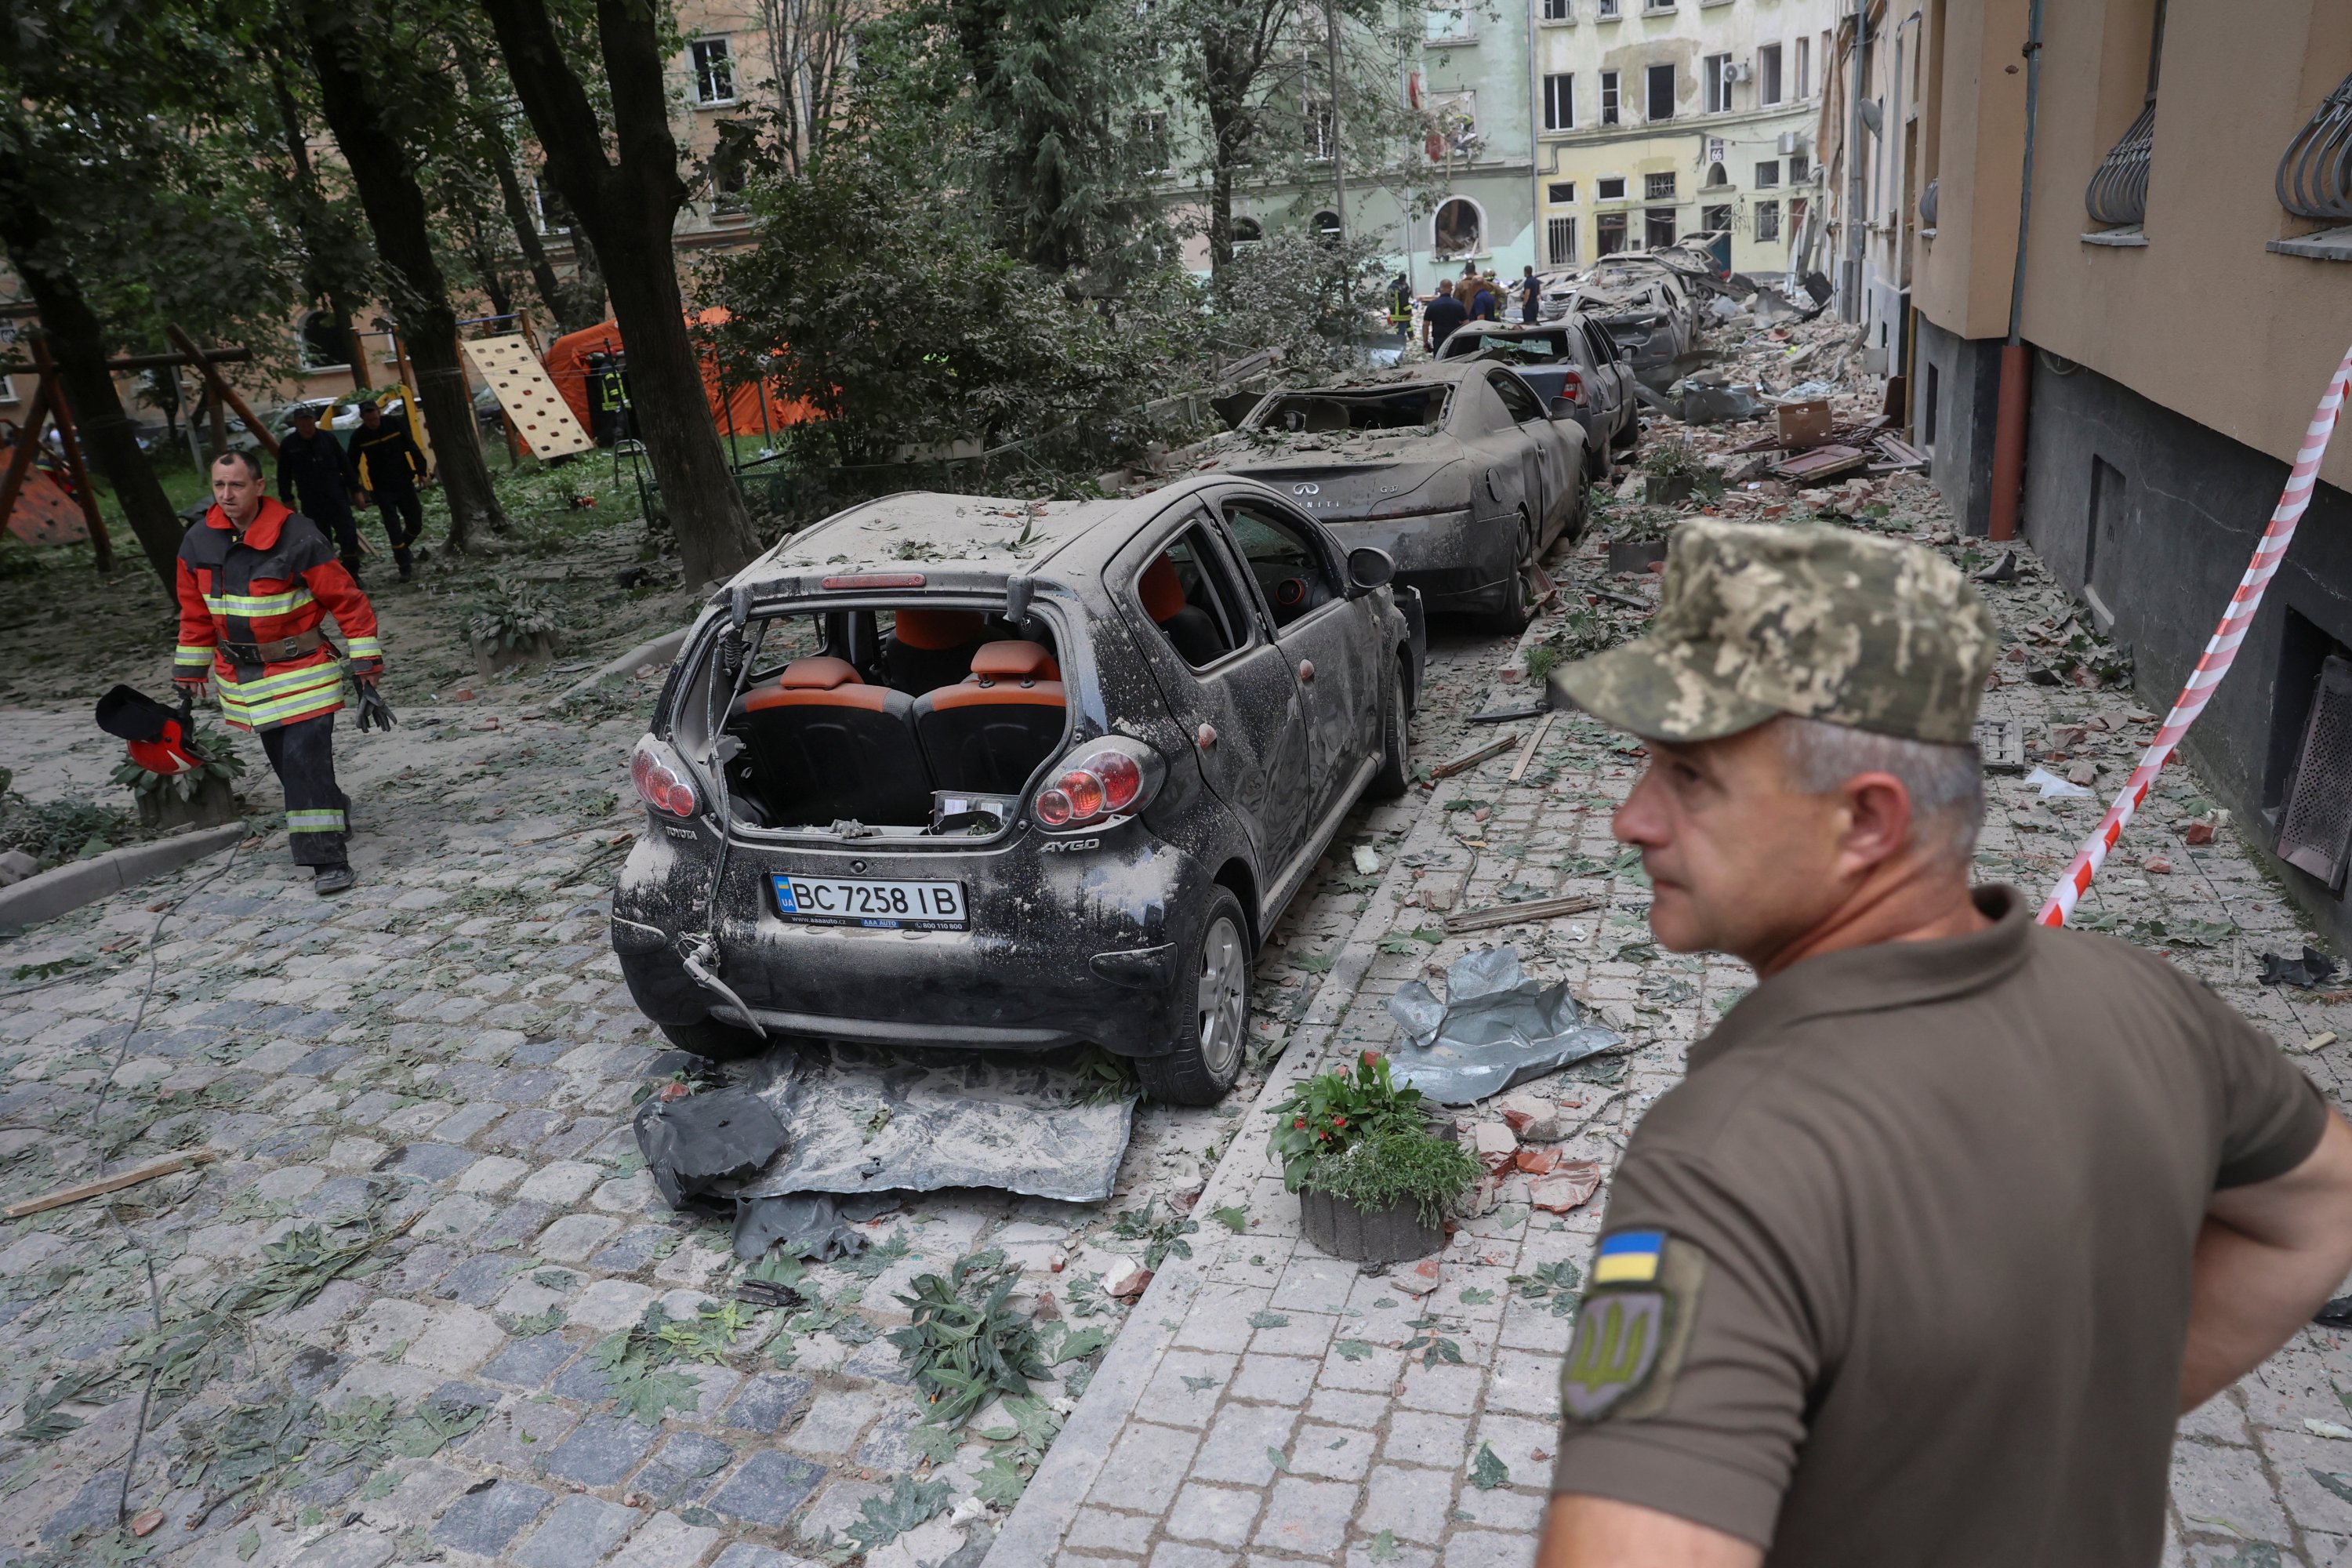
xmin=988 ymin=482 xmax=2352 ymax=1568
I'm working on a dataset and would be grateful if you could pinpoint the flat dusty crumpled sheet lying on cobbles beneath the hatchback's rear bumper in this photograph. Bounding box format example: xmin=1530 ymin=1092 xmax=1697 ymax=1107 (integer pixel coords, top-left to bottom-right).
xmin=736 ymin=1041 xmax=1136 ymax=1203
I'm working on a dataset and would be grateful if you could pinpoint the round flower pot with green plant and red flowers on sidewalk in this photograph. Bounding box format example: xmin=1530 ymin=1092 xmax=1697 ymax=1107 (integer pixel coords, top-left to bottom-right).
xmin=1265 ymin=1051 xmax=1479 ymax=1262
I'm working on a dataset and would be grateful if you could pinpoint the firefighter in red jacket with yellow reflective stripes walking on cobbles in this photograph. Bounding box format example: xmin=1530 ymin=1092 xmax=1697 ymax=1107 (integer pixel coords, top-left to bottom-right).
xmin=172 ymin=452 xmax=383 ymax=893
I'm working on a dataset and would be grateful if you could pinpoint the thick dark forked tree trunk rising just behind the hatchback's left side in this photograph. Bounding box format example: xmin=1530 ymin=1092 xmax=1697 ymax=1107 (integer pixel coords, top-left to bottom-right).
xmin=485 ymin=0 xmax=760 ymax=583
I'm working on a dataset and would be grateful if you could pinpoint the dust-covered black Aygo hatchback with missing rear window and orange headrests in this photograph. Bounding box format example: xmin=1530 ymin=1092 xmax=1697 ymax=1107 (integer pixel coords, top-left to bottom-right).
xmin=612 ymin=475 xmax=1425 ymax=1105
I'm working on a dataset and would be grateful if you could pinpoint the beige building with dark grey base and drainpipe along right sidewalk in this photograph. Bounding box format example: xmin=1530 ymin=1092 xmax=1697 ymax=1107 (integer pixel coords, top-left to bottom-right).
xmin=1823 ymin=0 xmax=2352 ymax=942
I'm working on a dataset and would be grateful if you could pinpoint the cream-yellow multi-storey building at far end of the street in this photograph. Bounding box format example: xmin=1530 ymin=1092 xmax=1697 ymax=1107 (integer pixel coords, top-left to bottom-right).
xmin=1531 ymin=0 xmax=1835 ymax=273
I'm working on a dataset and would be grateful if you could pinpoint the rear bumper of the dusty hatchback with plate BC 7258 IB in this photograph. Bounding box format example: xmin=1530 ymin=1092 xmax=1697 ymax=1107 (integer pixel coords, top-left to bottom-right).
xmin=612 ymin=820 xmax=1207 ymax=1055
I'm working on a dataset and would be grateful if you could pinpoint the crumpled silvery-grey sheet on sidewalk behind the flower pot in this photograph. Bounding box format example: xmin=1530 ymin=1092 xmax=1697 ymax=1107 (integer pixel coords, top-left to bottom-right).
xmin=1388 ymin=947 xmax=1625 ymax=1105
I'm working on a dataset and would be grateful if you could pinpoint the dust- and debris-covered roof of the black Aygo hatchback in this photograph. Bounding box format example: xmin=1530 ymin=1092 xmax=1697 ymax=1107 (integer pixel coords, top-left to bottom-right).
xmin=746 ymin=492 xmax=1124 ymax=581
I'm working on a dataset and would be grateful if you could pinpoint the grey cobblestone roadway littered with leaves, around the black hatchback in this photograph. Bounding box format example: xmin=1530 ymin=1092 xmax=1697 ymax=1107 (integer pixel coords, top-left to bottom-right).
xmin=0 ymin=571 xmax=1491 ymax=1568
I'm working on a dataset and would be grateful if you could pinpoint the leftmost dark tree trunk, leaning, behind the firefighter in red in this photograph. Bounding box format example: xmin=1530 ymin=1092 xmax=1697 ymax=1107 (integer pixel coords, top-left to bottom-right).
xmin=0 ymin=162 xmax=179 ymax=595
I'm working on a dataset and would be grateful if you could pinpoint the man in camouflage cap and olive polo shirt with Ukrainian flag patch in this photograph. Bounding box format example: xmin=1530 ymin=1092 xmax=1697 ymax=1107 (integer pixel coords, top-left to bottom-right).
xmin=1541 ymin=520 xmax=2352 ymax=1568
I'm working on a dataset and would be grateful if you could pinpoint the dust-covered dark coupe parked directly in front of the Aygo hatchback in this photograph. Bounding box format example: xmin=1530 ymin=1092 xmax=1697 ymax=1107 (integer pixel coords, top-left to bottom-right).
xmin=1185 ymin=360 xmax=1585 ymax=630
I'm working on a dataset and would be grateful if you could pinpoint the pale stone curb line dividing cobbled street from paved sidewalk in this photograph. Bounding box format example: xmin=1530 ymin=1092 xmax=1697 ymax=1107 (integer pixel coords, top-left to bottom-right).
xmin=983 ymin=648 xmax=1541 ymax=1568
